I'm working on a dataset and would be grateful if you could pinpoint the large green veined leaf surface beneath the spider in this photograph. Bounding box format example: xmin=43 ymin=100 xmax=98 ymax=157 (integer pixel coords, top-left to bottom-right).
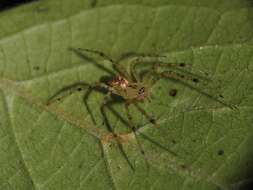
xmin=0 ymin=0 xmax=253 ymax=190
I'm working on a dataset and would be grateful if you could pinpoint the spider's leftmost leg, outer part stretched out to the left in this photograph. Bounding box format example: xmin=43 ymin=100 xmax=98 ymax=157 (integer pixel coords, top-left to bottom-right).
xmin=47 ymin=82 xmax=90 ymax=105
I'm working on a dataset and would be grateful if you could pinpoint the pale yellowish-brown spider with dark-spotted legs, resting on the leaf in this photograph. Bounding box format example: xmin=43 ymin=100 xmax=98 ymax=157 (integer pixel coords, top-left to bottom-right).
xmin=47 ymin=48 xmax=233 ymax=168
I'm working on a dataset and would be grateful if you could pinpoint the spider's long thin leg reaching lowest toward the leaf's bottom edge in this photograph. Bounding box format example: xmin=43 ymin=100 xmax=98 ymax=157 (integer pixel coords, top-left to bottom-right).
xmin=100 ymin=91 xmax=134 ymax=170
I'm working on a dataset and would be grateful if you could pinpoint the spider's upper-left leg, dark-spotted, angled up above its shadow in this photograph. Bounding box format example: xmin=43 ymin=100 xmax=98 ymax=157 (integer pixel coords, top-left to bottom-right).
xmin=75 ymin=48 xmax=132 ymax=81
